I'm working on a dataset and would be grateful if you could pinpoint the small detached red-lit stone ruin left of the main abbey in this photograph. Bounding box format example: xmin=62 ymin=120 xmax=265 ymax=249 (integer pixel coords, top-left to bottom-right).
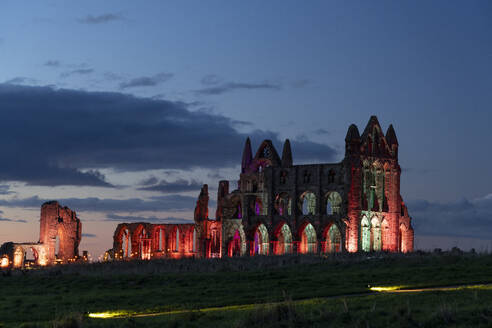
xmin=0 ymin=201 xmax=82 ymax=268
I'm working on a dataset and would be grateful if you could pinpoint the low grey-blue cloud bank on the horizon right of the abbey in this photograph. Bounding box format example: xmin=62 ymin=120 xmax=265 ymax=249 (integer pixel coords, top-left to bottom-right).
xmin=407 ymin=197 xmax=492 ymax=239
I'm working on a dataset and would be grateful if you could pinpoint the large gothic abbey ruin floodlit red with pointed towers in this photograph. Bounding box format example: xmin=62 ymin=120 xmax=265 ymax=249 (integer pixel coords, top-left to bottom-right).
xmin=108 ymin=116 xmax=414 ymax=259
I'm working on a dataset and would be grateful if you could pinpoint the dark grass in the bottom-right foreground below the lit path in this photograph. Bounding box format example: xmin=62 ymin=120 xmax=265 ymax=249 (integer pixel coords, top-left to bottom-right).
xmin=98 ymin=289 xmax=492 ymax=328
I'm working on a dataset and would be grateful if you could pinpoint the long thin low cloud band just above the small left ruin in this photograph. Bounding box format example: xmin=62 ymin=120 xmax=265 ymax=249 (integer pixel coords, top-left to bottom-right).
xmin=0 ymin=195 xmax=206 ymax=213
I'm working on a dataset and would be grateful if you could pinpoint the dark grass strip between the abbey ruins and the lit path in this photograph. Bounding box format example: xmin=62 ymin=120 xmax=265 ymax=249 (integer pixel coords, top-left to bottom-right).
xmin=0 ymin=254 xmax=492 ymax=326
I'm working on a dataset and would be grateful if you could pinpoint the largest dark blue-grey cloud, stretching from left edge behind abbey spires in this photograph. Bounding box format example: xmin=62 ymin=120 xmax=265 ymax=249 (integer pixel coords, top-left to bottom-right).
xmin=0 ymin=84 xmax=336 ymax=186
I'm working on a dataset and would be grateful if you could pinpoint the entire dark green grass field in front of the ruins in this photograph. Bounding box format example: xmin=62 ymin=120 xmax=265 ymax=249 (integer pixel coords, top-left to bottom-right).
xmin=0 ymin=253 xmax=492 ymax=327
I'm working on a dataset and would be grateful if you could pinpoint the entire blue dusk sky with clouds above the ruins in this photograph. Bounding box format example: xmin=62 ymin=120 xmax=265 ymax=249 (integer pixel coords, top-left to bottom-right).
xmin=0 ymin=0 xmax=492 ymax=258
